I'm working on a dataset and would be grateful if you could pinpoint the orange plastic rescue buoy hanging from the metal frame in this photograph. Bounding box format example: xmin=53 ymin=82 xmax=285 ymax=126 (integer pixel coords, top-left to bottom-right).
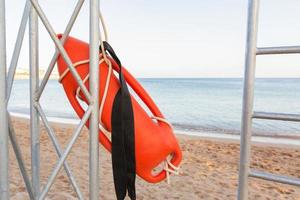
xmin=57 ymin=35 xmax=182 ymax=183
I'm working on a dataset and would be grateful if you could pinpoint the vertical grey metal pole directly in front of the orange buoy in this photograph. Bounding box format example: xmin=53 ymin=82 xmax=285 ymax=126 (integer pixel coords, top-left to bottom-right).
xmin=89 ymin=0 xmax=99 ymax=200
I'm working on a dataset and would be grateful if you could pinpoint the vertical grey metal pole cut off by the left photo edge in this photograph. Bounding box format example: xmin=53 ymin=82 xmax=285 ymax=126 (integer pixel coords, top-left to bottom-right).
xmin=0 ymin=0 xmax=9 ymax=200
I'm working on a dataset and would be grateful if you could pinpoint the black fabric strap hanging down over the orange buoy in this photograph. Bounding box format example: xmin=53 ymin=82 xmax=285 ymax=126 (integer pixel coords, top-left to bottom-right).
xmin=100 ymin=41 xmax=136 ymax=200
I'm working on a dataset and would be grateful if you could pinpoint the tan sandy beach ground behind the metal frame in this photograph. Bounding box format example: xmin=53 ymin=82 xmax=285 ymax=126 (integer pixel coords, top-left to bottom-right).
xmin=10 ymin=118 xmax=300 ymax=200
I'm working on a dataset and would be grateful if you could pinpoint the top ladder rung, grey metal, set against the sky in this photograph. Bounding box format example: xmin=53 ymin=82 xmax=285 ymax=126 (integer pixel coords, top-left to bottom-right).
xmin=256 ymin=46 xmax=300 ymax=55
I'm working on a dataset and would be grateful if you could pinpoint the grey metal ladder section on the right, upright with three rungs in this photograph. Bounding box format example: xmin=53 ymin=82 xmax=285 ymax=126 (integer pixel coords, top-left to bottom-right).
xmin=238 ymin=0 xmax=300 ymax=200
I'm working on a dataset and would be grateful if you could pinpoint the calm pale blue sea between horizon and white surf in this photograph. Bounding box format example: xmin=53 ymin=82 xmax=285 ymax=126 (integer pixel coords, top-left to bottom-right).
xmin=9 ymin=78 xmax=300 ymax=137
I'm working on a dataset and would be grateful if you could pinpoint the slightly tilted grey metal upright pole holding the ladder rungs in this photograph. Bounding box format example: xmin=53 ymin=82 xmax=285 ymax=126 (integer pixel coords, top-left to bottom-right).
xmin=238 ymin=0 xmax=259 ymax=200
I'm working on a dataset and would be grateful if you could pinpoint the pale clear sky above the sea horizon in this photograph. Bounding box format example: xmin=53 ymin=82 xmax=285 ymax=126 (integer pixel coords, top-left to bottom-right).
xmin=6 ymin=0 xmax=300 ymax=77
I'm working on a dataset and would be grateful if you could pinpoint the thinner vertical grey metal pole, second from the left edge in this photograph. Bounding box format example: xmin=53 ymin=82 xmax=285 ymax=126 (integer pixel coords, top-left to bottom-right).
xmin=29 ymin=1 xmax=40 ymax=199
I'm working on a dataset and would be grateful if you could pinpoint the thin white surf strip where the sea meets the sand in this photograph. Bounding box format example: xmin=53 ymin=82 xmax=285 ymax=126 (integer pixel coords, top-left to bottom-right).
xmin=10 ymin=113 xmax=300 ymax=148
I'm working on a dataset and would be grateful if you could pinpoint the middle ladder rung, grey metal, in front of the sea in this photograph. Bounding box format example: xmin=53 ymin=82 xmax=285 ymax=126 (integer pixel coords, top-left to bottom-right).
xmin=252 ymin=112 xmax=300 ymax=122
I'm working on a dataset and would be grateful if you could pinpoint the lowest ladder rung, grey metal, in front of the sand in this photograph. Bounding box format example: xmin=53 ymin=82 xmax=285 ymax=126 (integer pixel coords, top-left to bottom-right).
xmin=249 ymin=170 xmax=300 ymax=186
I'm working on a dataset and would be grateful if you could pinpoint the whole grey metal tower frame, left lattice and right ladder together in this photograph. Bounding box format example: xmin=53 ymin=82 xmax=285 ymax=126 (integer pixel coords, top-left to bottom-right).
xmin=0 ymin=0 xmax=300 ymax=200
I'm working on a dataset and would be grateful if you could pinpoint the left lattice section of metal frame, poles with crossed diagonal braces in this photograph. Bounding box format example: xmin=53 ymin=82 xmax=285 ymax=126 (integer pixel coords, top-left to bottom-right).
xmin=0 ymin=0 xmax=99 ymax=200
